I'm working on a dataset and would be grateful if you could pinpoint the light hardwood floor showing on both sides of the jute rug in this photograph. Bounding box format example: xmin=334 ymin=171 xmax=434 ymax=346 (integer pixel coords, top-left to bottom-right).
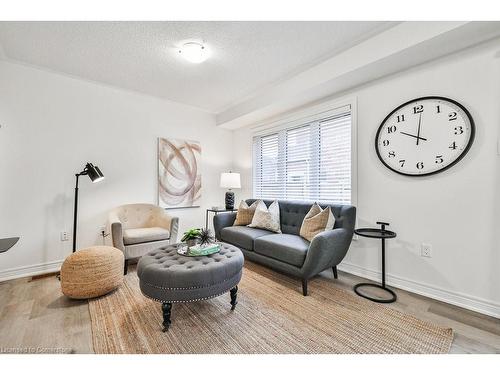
xmin=0 ymin=266 xmax=500 ymax=353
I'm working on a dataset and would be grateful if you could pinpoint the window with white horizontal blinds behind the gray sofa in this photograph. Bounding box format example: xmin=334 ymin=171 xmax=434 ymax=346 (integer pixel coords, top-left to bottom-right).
xmin=253 ymin=106 xmax=353 ymax=204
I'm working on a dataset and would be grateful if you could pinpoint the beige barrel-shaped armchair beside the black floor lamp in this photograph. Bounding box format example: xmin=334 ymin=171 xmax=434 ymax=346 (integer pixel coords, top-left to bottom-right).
xmin=108 ymin=203 xmax=179 ymax=274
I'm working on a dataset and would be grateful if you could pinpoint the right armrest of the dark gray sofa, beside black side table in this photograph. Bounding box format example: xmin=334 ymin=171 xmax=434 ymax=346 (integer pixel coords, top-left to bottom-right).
xmin=302 ymin=228 xmax=353 ymax=279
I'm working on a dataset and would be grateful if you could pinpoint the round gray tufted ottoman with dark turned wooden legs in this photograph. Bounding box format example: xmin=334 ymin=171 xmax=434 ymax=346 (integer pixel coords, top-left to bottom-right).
xmin=137 ymin=243 xmax=244 ymax=332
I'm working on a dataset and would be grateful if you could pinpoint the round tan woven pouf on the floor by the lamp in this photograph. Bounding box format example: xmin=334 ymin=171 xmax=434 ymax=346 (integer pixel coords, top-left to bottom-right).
xmin=61 ymin=246 xmax=125 ymax=299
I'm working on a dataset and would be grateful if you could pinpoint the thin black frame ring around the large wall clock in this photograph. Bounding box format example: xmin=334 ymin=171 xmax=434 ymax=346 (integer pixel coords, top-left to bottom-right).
xmin=375 ymin=96 xmax=476 ymax=177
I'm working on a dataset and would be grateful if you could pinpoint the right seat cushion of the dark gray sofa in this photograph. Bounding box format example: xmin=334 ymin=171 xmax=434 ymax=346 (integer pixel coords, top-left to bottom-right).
xmin=254 ymin=234 xmax=309 ymax=267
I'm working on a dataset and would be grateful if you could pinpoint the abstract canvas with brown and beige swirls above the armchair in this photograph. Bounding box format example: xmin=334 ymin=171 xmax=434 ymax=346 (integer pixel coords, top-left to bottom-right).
xmin=158 ymin=138 xmax=201 ymax=208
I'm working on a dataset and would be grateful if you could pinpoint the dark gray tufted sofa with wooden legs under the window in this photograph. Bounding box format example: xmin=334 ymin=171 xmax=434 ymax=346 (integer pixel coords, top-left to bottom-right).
xmin=214 ymin=199 xmax=356 ymax=296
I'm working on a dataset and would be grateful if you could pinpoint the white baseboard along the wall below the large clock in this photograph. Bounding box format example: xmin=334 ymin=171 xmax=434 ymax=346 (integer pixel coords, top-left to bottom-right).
xmin=338 ymin=262 xmax=500 ymax=318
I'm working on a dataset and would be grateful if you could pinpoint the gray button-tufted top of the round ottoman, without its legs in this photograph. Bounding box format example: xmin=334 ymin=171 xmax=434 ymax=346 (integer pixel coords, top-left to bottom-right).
xmin=137 ymin=243 xmax=244 ymax=294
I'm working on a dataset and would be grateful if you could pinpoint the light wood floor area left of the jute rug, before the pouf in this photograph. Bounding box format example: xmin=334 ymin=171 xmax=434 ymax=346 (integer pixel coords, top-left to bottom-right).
xmin=0 ymin=276 xmax=93 ymax=353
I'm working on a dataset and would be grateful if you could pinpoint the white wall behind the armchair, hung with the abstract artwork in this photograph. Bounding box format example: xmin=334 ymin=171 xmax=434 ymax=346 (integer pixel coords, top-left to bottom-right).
xmin=0 ymin=62 xmax=232 ymax=279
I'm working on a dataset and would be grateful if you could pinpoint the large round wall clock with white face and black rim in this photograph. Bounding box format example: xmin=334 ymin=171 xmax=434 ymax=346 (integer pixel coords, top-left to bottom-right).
xmin=375 ymin=96 xmax=475 ymax=176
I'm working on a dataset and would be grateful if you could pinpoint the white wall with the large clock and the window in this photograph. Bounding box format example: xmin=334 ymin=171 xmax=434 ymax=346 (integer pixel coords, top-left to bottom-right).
xmin=234 ymin=41 xmax=500 ymax=316
